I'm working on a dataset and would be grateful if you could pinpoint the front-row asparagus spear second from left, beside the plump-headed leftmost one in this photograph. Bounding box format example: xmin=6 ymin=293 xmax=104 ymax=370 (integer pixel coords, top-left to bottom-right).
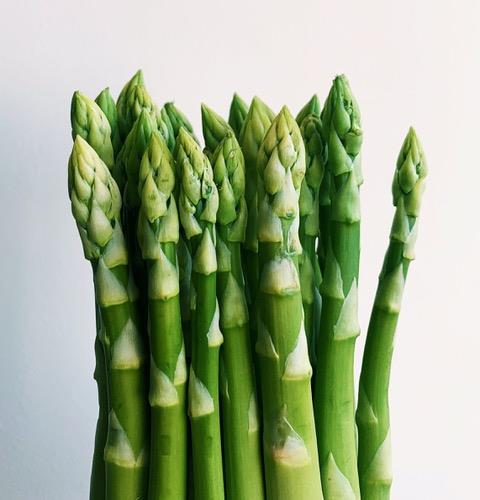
xmin=138 ymin=132 xmax=187 ymax=500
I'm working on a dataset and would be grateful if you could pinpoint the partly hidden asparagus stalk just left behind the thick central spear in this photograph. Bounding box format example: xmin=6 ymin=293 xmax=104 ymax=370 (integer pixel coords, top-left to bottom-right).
xmin=239 ymin=97 xmax=274 ymax=343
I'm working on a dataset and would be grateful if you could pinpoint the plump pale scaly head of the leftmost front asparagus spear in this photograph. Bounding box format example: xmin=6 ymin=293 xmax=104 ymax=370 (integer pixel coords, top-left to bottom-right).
xmin=68 ymin=135 xmax=124 ymax=261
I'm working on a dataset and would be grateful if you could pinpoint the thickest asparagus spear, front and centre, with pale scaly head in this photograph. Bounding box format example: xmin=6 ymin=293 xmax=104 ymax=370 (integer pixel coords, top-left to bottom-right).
xmin=256 ymin=107 xmax=323 ymax=500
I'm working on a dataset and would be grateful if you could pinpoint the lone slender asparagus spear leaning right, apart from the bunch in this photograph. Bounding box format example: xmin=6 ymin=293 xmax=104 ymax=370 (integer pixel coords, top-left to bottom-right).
xmin=357 ymin=129 xmax=427 ymax=500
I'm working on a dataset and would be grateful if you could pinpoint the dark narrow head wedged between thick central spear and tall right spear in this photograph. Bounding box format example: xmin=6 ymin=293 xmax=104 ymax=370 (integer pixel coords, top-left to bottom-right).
xmin=299 ymin=114 xmax=326 ymax=236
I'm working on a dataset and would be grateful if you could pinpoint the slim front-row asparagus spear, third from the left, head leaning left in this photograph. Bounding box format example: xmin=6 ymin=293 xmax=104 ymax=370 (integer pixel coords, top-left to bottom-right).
xmin=176 ymin=128 xmax=224 ymax=500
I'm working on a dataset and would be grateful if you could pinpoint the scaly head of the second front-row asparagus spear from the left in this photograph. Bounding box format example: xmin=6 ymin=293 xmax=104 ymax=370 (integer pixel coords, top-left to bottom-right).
xmin=138 ymin=132 xmax=179 ymax=259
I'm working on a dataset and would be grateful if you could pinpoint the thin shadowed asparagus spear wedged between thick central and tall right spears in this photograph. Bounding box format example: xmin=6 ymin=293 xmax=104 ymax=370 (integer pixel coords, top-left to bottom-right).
xmin=299 ymin=107 xmax=326 ymax=366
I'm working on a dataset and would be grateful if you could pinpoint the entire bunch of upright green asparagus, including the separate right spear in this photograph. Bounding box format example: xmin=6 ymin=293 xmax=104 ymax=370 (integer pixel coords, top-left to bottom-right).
xmin=68 ymin=72 xmax=427 ymax=500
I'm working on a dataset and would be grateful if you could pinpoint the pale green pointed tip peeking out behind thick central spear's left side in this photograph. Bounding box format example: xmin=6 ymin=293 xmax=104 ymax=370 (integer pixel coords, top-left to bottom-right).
xmin=239 ymin=97 xmax=274 ymax=168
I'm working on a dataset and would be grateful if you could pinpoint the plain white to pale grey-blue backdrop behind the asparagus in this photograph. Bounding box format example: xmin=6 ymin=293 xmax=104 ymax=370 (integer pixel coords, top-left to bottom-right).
xmin=0 ymin=0 xmax=480 ymax=500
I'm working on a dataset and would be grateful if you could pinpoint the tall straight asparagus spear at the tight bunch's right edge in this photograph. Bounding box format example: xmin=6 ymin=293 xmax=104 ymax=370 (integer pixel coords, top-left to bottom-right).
xmin=314 ymin=76 xmax=362 ymax=500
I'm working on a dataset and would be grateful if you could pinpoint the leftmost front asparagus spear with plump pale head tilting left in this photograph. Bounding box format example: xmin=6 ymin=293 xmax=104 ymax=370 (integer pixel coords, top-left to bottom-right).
xmin=68 ymin=136 xmax=148 ymax=500
